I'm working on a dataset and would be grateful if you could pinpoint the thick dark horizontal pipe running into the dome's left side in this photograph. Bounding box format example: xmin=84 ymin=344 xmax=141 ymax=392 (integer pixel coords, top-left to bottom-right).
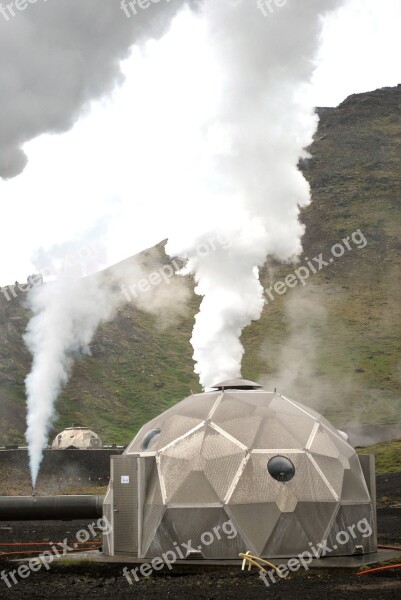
xmin=0 ymin=496 xmax=104 ymax=521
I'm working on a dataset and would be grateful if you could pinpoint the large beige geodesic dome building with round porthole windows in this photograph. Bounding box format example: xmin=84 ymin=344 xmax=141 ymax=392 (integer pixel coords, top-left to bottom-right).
xmin=104 ymin=380 xmax=377 ymax=560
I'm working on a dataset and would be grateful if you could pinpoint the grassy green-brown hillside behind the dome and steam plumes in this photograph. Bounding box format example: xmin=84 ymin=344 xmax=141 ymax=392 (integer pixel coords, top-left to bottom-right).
xmin=0 ymin=86 xmax=401 ymax=445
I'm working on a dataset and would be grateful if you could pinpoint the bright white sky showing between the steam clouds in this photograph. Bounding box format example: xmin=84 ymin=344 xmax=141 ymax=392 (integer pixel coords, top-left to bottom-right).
xmin=0 ymin=0 xmax=401 ymax=286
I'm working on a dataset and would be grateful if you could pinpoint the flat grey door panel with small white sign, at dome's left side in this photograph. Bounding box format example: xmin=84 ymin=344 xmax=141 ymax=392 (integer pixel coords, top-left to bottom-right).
xmin=111 ymin=456 xmax=139 ymax=556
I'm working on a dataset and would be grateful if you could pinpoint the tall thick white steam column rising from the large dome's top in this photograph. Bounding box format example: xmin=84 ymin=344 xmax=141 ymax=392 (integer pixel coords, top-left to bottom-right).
xmin=168 ymin=0 xmax=341 ymax=387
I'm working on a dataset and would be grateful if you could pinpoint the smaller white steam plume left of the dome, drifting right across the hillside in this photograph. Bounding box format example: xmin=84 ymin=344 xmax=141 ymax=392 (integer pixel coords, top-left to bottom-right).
xmin=24 ymin=244 xmax=191 ymax=486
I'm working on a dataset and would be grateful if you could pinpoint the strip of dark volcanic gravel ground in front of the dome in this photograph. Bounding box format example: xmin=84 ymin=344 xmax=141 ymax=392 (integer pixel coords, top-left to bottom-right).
xmin=0 ymin=565 xmax=401 ymax=600
